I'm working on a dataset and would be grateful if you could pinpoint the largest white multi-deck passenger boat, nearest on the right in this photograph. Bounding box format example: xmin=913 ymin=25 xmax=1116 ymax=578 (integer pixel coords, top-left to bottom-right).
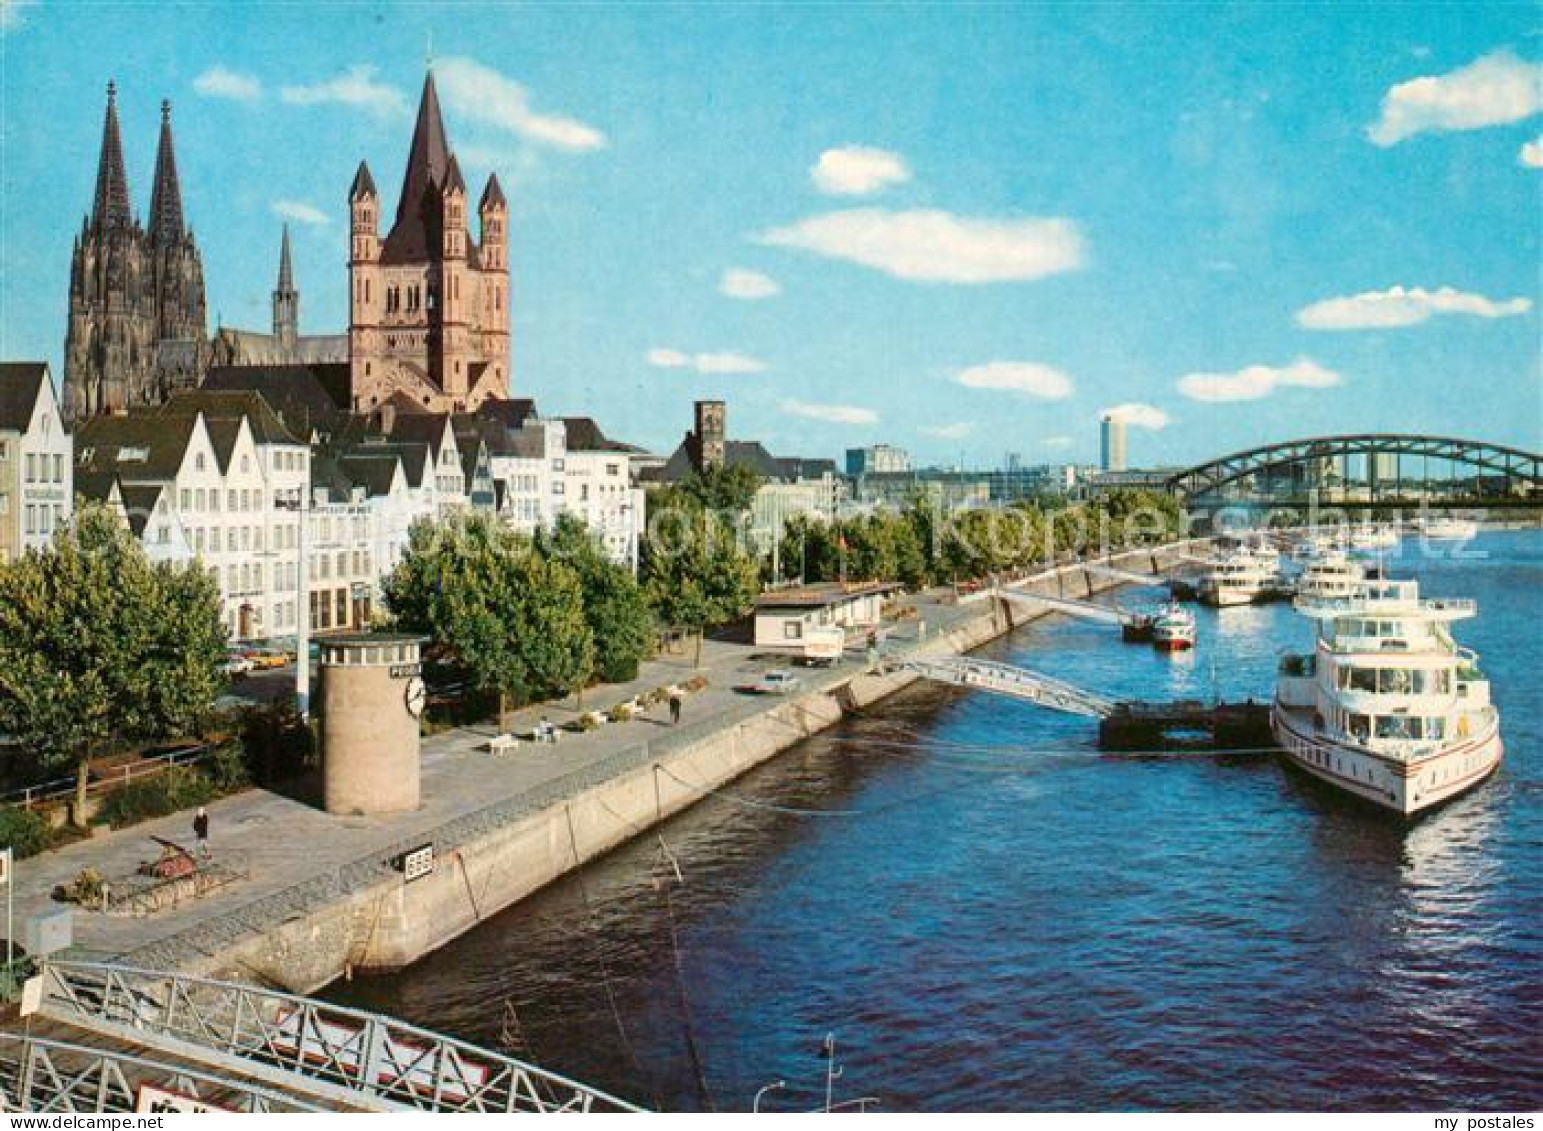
xmin=1270 ymin=579 xmax=1503 ymax=816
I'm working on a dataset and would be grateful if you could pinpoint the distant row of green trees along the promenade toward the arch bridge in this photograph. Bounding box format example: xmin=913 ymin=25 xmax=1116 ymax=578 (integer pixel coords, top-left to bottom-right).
xmin=778 ymin=491 xmax=1183 ymax=586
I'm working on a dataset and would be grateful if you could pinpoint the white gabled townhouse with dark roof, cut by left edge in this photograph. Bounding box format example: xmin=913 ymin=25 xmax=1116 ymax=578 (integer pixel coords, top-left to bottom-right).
xmin=0 ymin=361 xmax=74 ymax=562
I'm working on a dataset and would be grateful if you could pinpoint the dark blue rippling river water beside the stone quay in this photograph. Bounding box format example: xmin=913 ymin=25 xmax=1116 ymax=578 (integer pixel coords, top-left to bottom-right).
xmin=329 ymin=531 xmax=1543 ymax=1111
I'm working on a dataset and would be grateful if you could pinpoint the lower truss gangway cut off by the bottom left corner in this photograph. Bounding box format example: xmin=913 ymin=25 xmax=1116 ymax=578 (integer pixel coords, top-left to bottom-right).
xmin=0 ymin=1032 xmax=324 ymax=1114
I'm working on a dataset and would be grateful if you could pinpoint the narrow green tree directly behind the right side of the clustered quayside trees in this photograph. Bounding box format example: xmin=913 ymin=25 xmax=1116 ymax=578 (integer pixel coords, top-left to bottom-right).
xmin=535 ymin=514 xmax=656 ymax=684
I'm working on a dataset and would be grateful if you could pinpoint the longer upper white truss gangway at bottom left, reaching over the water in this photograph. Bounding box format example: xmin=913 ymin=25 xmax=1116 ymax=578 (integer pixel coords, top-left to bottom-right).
xmin=42 ymin=961 xmax=640 ymax=1112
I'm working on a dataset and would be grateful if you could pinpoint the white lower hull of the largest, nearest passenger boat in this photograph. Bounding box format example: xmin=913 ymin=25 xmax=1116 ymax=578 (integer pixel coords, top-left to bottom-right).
xmin=1270 ymin=702 xmax=1504 ymax=816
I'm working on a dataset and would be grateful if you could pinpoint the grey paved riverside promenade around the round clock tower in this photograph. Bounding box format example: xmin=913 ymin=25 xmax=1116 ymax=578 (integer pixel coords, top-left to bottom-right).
xmin=14 ymin=596 xmax=981 ymax=967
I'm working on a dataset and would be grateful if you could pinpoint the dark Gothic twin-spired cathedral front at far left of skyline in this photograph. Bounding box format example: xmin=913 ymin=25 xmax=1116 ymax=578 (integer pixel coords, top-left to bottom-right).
xmin=65 ymin=83 xmax=208 ymax=421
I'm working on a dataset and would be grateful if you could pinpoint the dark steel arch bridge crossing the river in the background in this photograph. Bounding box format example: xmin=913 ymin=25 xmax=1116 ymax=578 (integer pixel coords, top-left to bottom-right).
xmin=1168 ymin=432 xmax=1543 ymax=503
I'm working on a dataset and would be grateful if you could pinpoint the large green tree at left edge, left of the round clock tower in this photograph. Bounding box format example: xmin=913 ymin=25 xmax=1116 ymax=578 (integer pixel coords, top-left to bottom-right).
xmin=0 ymin=505 xmax=225 ymax=824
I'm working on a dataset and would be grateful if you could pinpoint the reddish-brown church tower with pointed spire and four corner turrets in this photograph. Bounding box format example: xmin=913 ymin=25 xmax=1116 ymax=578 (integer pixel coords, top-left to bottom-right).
xmin=349 ymin=71 xmax=509 ymax=412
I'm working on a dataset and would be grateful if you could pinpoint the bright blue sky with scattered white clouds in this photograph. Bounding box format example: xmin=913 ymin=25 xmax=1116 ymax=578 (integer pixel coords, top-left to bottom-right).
xmin=0 ymin=0 xmax=1543 ymax=466
